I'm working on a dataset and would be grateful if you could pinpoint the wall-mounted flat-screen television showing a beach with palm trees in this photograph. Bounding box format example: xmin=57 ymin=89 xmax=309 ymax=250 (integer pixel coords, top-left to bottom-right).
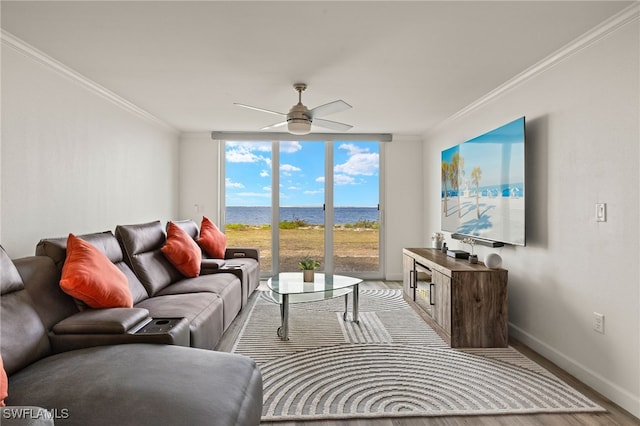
xmin=441 ymin=117 xmax=525 ymax=245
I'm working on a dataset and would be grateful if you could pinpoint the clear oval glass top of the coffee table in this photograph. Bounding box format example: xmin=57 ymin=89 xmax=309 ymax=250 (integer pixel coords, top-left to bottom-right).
xmin=267 ymin=272 xmax=362 ymax=294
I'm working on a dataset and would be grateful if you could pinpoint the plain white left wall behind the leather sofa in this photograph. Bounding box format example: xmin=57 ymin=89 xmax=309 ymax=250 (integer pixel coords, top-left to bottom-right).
xmin=0 ymin=45 xmax=178 ymax=257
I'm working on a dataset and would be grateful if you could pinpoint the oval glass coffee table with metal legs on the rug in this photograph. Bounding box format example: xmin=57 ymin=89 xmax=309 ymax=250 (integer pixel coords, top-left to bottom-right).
xmin=267 ymin=272 xmax=362 ymax=340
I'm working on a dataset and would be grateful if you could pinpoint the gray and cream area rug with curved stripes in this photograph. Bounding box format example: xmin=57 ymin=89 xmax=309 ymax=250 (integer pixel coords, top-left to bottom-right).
xmin=233 ymin=290 xmax=604 ymax=421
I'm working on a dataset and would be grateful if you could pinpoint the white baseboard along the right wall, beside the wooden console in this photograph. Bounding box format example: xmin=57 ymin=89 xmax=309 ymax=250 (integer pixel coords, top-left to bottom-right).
xmin=509 ymin=323 xmax=640 ymax=418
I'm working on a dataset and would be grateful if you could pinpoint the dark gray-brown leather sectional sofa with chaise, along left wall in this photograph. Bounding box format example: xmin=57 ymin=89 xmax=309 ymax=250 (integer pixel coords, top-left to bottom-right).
xmin=0 ymin=222 xmax=262 ymax=426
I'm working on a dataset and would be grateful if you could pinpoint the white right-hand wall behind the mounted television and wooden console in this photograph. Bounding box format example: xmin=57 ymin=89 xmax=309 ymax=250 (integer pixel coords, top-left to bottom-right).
xmin=424 ymin=18 xmax=640 ymax=417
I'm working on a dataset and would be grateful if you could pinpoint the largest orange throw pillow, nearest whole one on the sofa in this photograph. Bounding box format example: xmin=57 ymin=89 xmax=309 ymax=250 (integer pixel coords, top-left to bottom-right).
xmin=60 ymin=234 xmax=133 ymax=309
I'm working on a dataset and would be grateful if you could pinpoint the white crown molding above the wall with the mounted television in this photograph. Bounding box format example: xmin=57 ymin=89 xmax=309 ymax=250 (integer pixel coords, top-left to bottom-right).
xmin=425 ymin=2 xmax=640 ymax=136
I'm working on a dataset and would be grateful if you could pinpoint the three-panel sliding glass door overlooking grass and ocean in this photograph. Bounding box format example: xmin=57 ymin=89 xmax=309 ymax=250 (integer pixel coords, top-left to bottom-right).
xmin=223 ymin=141 xmax=382 ymax=278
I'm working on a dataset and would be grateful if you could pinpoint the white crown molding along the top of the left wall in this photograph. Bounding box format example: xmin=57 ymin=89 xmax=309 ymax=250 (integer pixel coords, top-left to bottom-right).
xmin=0 ymin=30 xmax=179 ymax=134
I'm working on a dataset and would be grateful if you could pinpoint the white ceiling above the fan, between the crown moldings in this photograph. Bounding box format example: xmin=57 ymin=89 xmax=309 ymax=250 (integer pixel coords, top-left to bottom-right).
xmin=1 ymin=1 xmax=632 ymax=135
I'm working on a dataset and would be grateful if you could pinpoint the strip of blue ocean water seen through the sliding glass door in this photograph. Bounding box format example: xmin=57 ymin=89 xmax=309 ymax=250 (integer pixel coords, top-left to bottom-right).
xmin=226 ymin=206 xmax=378 ymax=225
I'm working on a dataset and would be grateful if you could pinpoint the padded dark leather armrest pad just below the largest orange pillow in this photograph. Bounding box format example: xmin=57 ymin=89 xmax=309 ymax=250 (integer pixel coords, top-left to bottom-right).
xmin=53 ymin=308 xmax=149 ymax=334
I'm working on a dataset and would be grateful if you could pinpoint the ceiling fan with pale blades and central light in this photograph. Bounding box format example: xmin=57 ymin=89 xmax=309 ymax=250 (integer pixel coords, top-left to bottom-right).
xmin=235 ymin=83 xmax=353 ymax=135
